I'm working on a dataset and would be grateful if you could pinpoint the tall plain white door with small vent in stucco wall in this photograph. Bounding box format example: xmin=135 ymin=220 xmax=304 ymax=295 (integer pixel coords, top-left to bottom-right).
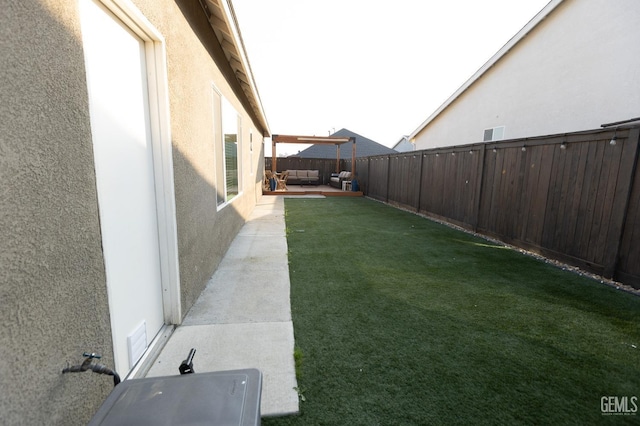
xmin=80 ymin=0 xmax=164 ymax=377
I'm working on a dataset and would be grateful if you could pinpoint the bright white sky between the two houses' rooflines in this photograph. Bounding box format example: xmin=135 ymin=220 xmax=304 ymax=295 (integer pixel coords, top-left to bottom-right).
xmin=233 ymin=0 xmax=549 ymax=154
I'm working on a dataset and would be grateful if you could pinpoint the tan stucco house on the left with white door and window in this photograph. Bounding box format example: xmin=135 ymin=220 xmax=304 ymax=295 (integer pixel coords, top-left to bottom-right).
xmin=0 ymin=0 xmax=269 ymax=425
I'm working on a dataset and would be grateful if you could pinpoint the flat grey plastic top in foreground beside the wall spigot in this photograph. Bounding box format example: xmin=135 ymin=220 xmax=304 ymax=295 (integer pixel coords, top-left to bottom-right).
xmin=89 ymin=369 xmax=262 ymax=426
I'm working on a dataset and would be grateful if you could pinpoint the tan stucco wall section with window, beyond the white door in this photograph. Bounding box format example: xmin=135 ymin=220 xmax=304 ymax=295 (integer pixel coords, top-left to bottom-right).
xmin=135 ymin=0 xmax=260 ymax=317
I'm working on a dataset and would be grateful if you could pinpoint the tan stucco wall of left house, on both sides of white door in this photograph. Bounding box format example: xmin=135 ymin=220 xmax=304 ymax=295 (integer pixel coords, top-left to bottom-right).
xmin=0 ymin=0 xmax=263 ymax=425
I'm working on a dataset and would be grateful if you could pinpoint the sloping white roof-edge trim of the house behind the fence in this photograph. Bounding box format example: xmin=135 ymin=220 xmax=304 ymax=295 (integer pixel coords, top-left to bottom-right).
xmin=408 ymin=0 xmax=564 ymax=141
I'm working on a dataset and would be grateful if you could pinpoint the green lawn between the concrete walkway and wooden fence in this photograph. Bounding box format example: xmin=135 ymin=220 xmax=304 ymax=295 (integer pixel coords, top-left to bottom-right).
xmin=263 ymin=197 xmax=640 ymax=425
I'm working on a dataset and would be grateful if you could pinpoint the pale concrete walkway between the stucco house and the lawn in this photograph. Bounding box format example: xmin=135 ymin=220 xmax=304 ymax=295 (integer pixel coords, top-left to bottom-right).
xmin=147 ymin=196 xmax=298 ymax=416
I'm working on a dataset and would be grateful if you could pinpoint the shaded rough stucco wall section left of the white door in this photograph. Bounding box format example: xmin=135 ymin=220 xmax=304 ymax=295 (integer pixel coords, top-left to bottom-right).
xmin=0 ymin=0 xmax=113 ymax=424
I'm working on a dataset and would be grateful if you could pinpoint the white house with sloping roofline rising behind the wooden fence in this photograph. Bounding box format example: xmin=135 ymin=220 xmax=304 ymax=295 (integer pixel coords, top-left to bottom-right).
xmin=409 ymin=0 xmax=640 ymax=149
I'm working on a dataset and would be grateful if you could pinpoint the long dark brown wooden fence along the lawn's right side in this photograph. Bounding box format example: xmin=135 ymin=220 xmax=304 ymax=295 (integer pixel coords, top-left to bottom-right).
xmin=356 ymin=127 xmax=640 ymax=288
